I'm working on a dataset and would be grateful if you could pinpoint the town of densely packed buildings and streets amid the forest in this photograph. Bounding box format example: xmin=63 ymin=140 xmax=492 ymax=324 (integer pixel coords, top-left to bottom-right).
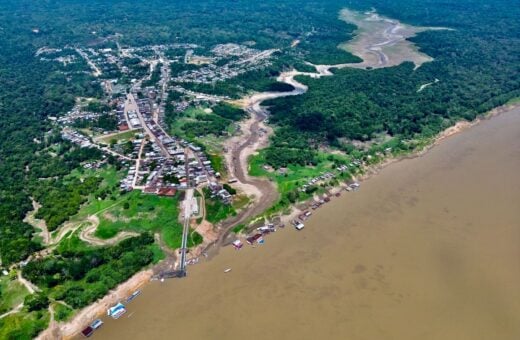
xmin=40 ymin=41 xmax=275 ymax=203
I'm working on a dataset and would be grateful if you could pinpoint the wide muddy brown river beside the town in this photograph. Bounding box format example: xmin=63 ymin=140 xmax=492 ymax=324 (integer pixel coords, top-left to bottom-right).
xmin=94 ymin=110 xmax=520 ymax=340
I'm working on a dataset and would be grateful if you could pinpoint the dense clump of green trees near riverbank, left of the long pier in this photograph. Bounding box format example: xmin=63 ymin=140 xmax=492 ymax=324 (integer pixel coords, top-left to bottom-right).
xmin=23 ymin=233 xmax=154 ymax=308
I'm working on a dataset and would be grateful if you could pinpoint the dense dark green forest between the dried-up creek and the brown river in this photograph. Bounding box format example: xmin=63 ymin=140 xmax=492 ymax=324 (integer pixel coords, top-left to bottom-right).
xmin=266 ymin=1 xmax=520 ymax=167
